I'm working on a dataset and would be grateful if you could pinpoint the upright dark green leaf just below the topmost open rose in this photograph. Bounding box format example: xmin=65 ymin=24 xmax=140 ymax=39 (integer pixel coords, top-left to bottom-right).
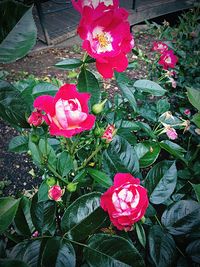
xmin=77 ymin=68 xmax=101 ymax=106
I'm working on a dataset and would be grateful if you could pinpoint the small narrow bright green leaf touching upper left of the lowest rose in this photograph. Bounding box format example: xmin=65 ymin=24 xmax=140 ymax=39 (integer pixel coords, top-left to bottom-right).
xmin=87 ymin=168 xmax=113 ymax=188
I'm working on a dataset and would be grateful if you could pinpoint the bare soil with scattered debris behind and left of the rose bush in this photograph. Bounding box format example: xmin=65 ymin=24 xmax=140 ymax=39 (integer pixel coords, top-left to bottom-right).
xmin=0 ymin=30 xmax=152 ymax=196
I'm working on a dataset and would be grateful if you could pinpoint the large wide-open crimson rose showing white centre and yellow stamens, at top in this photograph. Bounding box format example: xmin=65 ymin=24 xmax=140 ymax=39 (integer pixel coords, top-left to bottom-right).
xmin=73 ymin=2 xmax=134 ymax=78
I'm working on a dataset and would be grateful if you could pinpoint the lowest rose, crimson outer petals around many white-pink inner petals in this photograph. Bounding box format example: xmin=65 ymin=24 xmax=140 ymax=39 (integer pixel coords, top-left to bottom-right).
xmin=100 ymin=173 xmax=149 ymax=231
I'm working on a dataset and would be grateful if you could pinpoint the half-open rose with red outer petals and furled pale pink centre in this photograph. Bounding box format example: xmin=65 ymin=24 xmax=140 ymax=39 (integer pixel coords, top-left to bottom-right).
xmin=34 ymin=84 xmax=95 ymax=137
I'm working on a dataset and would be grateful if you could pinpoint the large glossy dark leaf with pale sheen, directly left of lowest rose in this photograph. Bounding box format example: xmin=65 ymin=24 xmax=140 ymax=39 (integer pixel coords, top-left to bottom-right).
xmin=61 ymin=192 xmax=107 ymax=240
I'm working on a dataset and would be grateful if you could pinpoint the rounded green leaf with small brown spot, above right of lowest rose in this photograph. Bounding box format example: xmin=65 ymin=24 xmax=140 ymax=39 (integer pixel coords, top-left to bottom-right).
xmin=134 ymin=141 xmax=160 ymax=168
